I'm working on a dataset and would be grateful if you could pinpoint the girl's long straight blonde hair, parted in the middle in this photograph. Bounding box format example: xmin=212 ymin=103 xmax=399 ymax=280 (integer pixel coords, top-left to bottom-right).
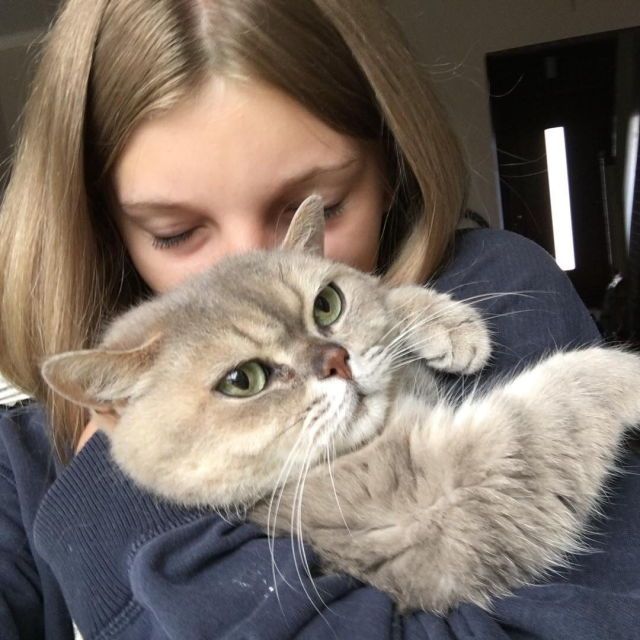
xmin=0 ymin=0 xmax=466 ymax=460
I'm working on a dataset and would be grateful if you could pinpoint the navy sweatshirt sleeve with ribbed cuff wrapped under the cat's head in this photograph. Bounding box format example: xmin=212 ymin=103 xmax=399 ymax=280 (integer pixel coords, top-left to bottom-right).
xmin=35 ymin=433 xmax=393 ymax=640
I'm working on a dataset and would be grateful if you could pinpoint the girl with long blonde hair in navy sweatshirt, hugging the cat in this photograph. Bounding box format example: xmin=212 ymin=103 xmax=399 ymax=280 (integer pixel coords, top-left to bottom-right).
xmin=0 ymin=0 xmax=640 ymax=640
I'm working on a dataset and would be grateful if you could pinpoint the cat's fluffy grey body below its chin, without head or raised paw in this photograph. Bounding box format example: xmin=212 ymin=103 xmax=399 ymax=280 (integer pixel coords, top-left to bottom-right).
xmin=249 ymin=348 xmax=640 ymax=612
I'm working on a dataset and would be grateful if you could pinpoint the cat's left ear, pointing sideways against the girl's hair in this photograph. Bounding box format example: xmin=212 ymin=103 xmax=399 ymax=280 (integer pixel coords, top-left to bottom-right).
xmin=41 ymin=334 xmax=162 ymax=411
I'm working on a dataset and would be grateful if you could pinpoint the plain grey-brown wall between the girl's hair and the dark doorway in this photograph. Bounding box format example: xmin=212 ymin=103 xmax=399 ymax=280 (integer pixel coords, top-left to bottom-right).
xmin=386 ymin=0 xmax=640 ymax=226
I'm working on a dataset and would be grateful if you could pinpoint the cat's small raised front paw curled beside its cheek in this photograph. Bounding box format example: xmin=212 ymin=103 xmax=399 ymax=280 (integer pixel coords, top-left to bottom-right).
xmin=387 ymin=285 xmax=491 ymax=374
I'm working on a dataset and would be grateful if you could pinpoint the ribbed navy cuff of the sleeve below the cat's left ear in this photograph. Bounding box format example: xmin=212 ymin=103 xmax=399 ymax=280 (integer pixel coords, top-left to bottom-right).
xmin=34 ymin=432 xmax=202 ymax=635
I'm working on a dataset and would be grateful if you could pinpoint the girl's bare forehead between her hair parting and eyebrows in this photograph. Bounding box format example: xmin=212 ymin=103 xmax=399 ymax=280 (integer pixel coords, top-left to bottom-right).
xmin=114 ymin=79 xmax=366 ymax=208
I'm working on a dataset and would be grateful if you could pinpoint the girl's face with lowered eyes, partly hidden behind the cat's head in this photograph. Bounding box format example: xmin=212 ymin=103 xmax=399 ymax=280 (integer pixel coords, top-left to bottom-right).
xmin=114 ymin=80 xmax=388 ymax=292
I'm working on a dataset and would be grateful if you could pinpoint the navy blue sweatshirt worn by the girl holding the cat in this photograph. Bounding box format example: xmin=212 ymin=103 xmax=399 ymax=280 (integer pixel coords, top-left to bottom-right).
xmin=0 ymin=230 xmax=640 ymax=640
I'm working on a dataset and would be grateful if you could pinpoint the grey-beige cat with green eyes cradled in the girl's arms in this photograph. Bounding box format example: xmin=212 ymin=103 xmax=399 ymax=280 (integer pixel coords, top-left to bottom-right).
xmin=42 ymin=196 xmax=640 ymax=613
